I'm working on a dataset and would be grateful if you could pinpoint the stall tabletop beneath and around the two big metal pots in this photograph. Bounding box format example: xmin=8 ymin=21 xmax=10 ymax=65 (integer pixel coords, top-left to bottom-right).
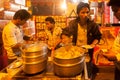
xmin=0 ymin=58 xmax=88 ymax=80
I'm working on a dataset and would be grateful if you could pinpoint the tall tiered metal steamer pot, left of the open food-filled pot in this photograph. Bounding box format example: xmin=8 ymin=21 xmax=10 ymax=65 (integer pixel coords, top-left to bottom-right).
xmin=22 ymin=43 xmax=48 ymax=74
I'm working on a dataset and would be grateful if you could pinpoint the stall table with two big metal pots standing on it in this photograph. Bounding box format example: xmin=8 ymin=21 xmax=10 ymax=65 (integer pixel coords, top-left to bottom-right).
xmin=0 ymin=42 xmax=88 ymax=80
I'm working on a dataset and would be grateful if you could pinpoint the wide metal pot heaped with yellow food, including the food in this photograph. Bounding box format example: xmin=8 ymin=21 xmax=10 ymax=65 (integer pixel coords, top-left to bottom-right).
xmin=53 ymin=46 xmax=85 ymax=77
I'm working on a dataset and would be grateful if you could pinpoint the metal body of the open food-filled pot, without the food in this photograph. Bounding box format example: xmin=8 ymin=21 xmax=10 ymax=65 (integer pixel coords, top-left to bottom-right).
xmin=53 ymin=46 xmax=85 ymax=77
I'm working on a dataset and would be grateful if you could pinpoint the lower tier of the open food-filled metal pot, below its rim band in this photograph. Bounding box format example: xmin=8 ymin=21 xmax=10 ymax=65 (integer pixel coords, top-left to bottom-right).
xmin=53 ymin=57 xmax=84 ymax=77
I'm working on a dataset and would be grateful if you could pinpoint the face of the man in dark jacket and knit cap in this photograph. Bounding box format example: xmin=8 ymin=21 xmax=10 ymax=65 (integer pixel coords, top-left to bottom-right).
xmin=78 ymin=7 xmax=90 ymax=21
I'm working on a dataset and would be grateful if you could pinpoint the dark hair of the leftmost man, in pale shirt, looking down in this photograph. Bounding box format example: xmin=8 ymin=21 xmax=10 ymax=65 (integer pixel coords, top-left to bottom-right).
xmin=13 ymin=9 xmax=31 ymax=20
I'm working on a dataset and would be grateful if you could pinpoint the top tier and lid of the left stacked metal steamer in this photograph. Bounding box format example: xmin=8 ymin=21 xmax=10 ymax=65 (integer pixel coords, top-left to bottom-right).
xmin=22 ymin=42 xmax=48 ymax=56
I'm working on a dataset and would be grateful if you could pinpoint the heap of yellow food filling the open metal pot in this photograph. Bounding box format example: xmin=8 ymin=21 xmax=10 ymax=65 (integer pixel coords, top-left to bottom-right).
xmin=54 ymin=46 xmax=85 ymax=59
